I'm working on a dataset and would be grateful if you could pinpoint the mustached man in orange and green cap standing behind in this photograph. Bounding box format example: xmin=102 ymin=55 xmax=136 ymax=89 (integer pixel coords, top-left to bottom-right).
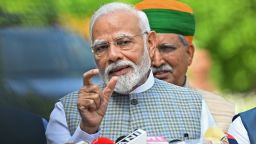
xmin=136 ymin=0 xmax=235 ymax=131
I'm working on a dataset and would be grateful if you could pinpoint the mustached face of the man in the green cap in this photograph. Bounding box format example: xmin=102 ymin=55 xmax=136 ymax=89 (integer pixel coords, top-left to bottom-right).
xmin=151 ymin=34 xmax=194 ymax=86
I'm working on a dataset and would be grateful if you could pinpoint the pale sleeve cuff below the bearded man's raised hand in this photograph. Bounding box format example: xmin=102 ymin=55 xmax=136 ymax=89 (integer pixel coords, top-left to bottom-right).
xmin=69 ymin=126 xmax=100 ymax=143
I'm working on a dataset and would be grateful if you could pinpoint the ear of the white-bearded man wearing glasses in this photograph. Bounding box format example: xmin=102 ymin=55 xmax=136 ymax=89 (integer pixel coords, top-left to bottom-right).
xmin=148 ymin=31 xmax=156 ymax=59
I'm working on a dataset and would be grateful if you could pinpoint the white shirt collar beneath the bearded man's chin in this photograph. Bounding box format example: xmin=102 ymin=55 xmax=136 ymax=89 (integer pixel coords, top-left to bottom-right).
xmin=130 ymin=71 xmax=155 ymax=94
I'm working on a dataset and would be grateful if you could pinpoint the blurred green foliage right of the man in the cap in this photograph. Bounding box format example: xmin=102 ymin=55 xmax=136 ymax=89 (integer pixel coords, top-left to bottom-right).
xmin=180 ymin=0 xmax=256 ymax=92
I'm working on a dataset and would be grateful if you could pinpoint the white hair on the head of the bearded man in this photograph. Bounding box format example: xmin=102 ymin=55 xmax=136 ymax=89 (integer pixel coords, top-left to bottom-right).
xmin=90 ymin=2 xmax=150 ymax=40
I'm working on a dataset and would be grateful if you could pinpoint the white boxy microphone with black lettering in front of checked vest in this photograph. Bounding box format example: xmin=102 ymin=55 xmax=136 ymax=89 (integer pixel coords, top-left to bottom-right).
xmin=116 ymin=129 xmax=147 ymax=144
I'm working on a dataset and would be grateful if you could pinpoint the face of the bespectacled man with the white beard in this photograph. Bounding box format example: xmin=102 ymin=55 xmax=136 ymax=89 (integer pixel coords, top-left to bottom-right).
xmin=92 ymin=11 xmax=150 ymax=93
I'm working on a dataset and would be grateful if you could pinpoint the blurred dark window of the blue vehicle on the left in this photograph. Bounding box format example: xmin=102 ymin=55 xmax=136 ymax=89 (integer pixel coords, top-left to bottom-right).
xmin=0 ymin=27 xmax=95 ymax=75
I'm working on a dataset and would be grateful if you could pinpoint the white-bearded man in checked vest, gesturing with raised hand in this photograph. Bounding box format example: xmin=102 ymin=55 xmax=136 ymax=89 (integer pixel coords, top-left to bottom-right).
xmin=46 ymin=3 xmax=214 ymax=144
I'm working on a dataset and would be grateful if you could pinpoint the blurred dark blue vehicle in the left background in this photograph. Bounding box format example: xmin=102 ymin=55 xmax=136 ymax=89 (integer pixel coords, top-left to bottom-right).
xmin=0 ymin=28 xmax=100 ymax=100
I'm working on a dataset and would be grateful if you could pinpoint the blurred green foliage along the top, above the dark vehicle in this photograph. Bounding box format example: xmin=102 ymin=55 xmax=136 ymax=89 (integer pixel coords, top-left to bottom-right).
xmin=0 ymin=0 xmax=138 ymax=27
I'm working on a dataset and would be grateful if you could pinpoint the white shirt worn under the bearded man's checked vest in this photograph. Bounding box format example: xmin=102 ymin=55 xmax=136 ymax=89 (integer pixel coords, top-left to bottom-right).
xmin=46 ymin=72 xmax=215 ymax=144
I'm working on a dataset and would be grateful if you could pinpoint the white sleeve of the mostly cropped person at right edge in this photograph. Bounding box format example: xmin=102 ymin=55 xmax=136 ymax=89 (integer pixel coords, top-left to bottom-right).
xmin=228 ymin=116 xmax=250 ymax=144
